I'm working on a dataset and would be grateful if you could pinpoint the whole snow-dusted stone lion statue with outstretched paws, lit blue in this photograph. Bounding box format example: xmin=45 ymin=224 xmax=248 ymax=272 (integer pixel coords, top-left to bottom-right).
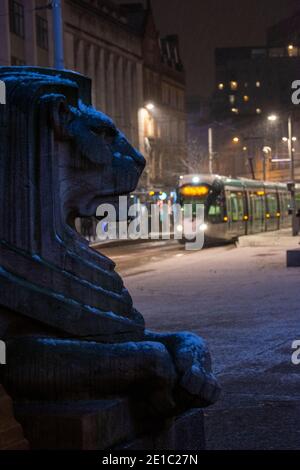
xmin=0 ymin=67 xmax=219 ymax=415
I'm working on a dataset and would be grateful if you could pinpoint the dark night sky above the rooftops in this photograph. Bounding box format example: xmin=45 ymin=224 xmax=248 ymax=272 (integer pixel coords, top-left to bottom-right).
xmin=119 ymin=0 xmax=300 ymax=98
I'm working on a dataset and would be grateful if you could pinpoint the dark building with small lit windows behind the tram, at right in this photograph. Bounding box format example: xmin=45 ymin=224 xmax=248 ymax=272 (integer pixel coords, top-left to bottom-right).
xmin=212 ymin=43 xmax=300 ymax=181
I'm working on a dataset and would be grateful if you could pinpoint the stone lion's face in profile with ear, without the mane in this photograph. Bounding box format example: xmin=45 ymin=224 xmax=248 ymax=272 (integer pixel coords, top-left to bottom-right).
xmin=50 ymin=95 xmax=145 ymax=223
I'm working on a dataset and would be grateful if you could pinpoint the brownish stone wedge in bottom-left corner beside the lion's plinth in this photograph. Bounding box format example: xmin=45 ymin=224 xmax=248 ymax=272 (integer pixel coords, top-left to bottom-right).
xmin=0 ymin=385 xmax=28 ymax=450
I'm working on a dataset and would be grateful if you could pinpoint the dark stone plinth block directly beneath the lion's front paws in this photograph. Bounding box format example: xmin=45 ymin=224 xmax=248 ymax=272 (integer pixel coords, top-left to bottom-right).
xmin=16 ymin=398 xmax=205 ymax=450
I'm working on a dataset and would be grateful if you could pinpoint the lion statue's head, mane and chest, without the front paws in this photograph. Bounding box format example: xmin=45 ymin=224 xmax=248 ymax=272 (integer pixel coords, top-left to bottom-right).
xmin=0 ymin=67 xmax=145 ymax=341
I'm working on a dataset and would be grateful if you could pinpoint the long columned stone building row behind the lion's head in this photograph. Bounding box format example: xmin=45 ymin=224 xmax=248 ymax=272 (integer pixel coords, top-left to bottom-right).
xmin=0 ymin=0 xmax=186 ymax=188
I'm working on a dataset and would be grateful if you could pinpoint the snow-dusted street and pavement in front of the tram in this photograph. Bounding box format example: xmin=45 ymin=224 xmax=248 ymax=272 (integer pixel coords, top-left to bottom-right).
xmin=101 ymin=231 xmax=300 ymax=449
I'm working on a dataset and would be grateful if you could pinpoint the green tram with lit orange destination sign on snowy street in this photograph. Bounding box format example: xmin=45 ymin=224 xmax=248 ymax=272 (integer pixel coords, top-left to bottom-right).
xmin=178 ymin=175 xmax=300 ymax=242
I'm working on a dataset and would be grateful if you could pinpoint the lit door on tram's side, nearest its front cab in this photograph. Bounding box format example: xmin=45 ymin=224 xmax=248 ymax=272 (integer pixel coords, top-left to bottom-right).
xmin=227 ymin=191 xmax=247 ymax=237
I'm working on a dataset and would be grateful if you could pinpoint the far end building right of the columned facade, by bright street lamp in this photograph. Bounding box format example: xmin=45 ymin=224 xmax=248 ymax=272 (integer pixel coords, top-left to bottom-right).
xmin=124 ymin=4 xmax=187 ymax=187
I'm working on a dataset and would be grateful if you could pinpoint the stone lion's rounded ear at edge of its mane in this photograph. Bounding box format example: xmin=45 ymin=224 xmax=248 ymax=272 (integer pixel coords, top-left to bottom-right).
xmin=50 ymin=95 xmax=73 ymax=140
